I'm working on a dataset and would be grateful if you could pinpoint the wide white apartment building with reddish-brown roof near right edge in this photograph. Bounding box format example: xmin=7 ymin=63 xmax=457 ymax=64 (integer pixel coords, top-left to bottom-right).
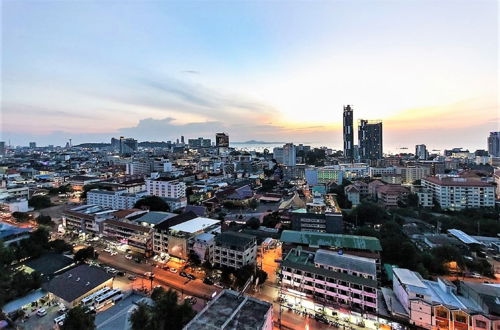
xmin=422 ymin=176 xmax=495 ymax=210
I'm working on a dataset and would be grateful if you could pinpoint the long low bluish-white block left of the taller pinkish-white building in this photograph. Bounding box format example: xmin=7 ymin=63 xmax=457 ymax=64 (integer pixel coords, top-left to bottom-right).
xmin=87 ymin=189 xmax=146 ymax=210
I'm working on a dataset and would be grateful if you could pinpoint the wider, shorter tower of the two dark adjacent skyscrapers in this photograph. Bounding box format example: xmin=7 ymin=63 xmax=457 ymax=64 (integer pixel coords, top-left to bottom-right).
xmin=358 ymin=119 xmax=383 ymax=160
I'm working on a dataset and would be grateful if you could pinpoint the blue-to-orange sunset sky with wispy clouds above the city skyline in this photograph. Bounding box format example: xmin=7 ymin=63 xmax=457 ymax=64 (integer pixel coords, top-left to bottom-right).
xmin=0 ymin=0 xmax=499 ymax=150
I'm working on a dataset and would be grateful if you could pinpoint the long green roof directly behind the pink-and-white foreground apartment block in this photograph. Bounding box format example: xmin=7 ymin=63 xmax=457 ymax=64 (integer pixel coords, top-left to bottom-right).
xmin=281 ymin=230 xmax=382 ymax=251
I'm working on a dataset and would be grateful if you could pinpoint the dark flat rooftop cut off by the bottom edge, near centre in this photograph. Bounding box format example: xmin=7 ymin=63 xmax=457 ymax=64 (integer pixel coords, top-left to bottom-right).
xmin=184 ymin=290 xmax=272 ymax=330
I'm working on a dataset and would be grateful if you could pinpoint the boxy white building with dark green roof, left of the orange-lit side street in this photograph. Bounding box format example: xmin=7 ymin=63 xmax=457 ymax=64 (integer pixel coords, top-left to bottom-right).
xmin=212 ymin=231 xmax=257 ymax=269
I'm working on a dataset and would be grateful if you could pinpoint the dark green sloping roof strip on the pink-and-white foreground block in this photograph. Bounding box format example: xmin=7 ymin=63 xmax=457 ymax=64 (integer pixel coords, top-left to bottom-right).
xmin=281 ymin=249 xmax=377 ymax=288
